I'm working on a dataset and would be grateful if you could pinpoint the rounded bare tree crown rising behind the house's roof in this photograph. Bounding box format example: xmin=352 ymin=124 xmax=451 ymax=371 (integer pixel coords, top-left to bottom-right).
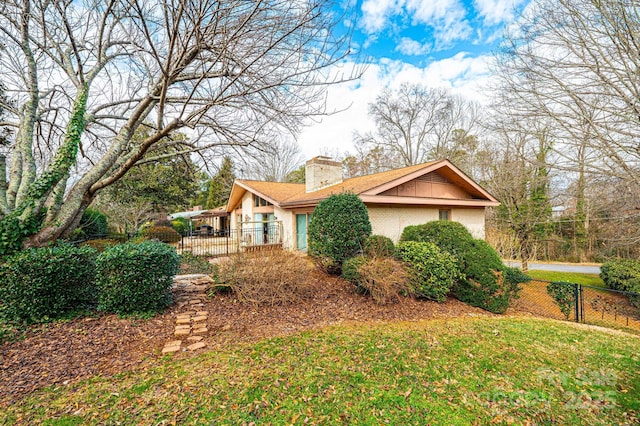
xmin=355 ymin=83 xmax=478 ymax=166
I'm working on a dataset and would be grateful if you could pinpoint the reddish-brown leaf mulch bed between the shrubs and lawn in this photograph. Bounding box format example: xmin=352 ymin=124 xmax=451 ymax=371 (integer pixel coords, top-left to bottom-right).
xmin=0 ymin=271 xmax=490 ymax=407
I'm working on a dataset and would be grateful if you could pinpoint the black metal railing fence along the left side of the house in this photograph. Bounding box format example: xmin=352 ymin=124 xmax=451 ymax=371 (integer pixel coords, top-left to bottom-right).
xmin=84 ymin=222 xmax=283 ymax=257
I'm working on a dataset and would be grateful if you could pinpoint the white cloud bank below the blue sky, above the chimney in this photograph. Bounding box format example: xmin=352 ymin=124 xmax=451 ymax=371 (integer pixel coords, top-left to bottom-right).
xmin=298 ymin=53 xmax=490 ymax=158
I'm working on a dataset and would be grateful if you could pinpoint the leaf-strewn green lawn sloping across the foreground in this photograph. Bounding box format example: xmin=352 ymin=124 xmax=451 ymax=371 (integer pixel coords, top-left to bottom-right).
xmin=0 ymin=317 xmax=640 ymax=425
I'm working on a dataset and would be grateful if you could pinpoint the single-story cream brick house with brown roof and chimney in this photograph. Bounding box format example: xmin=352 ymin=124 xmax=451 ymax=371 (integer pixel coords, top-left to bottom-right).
xmin=226 ymin=156 xmax=500 ymax=251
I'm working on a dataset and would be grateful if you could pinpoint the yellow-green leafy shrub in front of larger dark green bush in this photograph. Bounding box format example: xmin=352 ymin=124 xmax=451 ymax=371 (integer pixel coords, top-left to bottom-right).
xmin=396 ymin=241 xmax=464 ymax=302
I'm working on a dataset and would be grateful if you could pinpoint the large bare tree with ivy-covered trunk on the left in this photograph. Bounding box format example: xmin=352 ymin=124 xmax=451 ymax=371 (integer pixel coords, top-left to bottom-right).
xmin=0 ymin=0 xmax=359 ymax=254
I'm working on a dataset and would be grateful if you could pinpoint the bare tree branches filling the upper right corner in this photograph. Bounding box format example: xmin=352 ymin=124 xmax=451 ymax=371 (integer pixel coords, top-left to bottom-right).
xmin=497 ymin=0 xmax=640 ymax=185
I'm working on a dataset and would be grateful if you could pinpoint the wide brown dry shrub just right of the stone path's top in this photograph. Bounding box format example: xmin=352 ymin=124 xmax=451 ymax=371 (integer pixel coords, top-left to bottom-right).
xmin=218 ymin=249 xmax=312 ymax=306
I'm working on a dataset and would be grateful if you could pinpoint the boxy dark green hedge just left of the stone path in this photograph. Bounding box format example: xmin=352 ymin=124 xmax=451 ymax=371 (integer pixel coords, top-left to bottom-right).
xmin=96 ymin=241 xmax=180 ymax=314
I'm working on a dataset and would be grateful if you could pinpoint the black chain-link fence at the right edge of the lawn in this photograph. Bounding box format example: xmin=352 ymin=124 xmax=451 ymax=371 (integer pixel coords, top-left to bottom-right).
xmin=511 ymin=280 xmax=640 ymax=333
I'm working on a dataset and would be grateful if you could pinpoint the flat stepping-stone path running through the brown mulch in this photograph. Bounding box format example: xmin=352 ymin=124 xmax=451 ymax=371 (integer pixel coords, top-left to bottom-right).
xmin=162 ymin=274 xmax=214 ymax=354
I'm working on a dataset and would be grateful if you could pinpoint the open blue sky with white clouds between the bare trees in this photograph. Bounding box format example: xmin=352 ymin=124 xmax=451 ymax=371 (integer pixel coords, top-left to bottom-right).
xmin=299 ymin=0 xmax=529 ymax=158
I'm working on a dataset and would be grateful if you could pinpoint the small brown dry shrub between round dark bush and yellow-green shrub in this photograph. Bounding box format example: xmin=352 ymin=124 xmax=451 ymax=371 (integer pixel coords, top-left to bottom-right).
xmin=358 ymin=257 xmax=411 ymax=305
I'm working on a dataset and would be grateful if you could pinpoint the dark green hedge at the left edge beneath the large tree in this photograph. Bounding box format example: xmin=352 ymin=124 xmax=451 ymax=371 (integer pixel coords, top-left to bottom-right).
xmin=0 ymin=244 xmax=96 ymax=324
